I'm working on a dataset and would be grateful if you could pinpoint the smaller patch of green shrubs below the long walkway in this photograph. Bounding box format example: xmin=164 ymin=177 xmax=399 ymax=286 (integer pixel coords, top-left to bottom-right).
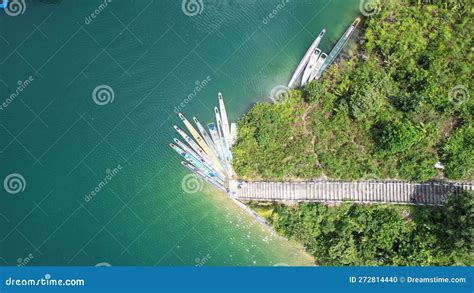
xmin=250 ymin=193 xmax=474 ymax=266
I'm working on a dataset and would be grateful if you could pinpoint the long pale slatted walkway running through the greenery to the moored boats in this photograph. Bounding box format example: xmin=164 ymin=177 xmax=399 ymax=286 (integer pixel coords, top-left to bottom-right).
xmin=229 ymin=180 xmax=474 ymax=205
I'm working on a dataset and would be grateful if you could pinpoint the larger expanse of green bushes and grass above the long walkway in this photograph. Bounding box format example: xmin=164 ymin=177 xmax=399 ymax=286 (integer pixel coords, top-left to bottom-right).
xmin=233 ymin=1 xmax=474 ymax=181
